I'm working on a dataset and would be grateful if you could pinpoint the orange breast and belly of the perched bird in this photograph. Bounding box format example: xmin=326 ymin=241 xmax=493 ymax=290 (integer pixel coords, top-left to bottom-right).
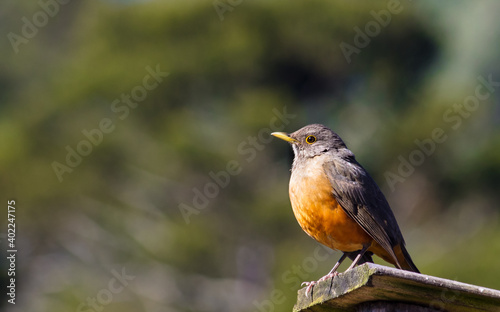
xmin=289 ymin=162 xmax=373 ymax=252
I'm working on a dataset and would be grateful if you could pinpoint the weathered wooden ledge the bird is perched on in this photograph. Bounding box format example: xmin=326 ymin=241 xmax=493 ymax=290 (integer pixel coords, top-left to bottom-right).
xmin=294 ymin=263 xmax=500 ymax=312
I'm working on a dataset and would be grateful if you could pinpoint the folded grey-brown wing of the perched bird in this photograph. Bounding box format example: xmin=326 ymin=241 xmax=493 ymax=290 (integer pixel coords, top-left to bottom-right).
xmin=323 ymin=157 xmax=404 ymax=264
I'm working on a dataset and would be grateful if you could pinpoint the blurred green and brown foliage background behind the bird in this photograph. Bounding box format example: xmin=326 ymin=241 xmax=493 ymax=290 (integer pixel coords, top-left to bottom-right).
xmin=0 ymin=0 xmax=500 ymax=312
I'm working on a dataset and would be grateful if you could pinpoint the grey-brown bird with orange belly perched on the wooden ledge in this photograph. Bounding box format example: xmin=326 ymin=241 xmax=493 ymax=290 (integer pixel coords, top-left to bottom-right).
xmin=271 ymin=124 xmax=420 ymax=296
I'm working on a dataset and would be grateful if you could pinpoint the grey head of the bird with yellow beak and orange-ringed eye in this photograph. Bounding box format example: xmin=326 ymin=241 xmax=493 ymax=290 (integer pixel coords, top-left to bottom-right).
xmin=272 ymin=124 xmax=353 ymax=158
